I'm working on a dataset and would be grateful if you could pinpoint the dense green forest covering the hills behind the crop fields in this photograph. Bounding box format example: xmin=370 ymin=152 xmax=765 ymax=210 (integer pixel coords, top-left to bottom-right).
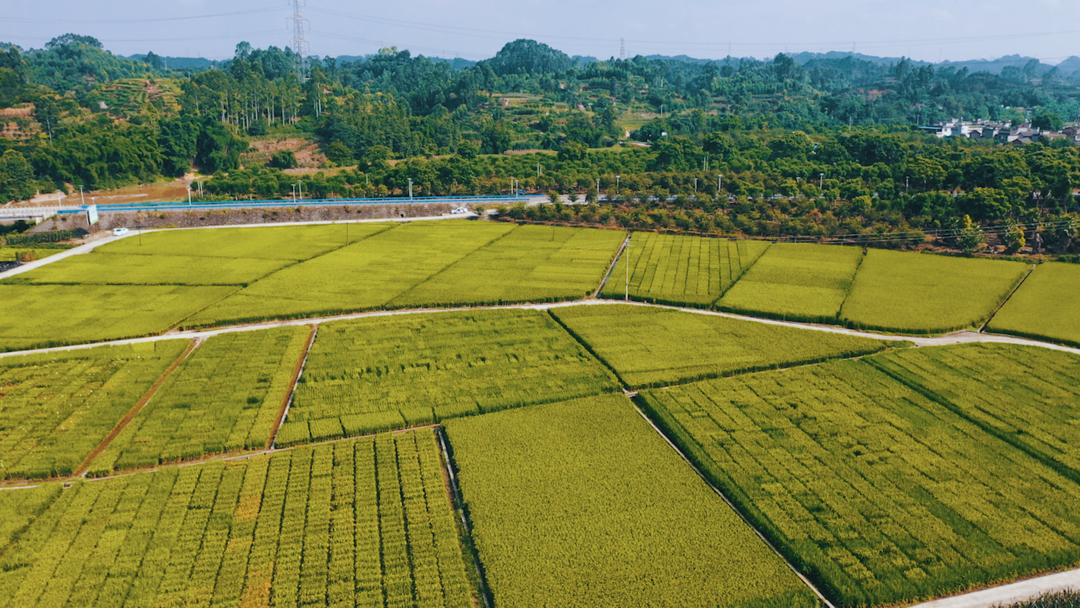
xmin=0 ymin=35 xmax=1080 ymax=251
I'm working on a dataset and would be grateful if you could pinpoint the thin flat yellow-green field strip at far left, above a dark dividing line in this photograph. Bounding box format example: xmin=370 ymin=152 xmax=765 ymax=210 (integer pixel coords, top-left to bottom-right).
xmin=3 ymin=252 xmax=292 ymax=285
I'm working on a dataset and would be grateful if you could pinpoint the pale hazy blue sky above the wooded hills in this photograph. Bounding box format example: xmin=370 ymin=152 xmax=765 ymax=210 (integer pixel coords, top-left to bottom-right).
xmin=0 ymin=0 xmax=1080 ymax=64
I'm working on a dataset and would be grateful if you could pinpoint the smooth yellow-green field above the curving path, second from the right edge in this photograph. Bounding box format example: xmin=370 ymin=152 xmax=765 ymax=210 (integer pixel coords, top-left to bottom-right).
xmin=840 ymin=249 xmax=1028 ymax=334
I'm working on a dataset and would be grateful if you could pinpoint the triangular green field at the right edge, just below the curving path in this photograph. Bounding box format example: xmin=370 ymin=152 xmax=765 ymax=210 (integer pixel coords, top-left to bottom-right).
xmin=868 ymin=344 xmax=1080 ymax=483
